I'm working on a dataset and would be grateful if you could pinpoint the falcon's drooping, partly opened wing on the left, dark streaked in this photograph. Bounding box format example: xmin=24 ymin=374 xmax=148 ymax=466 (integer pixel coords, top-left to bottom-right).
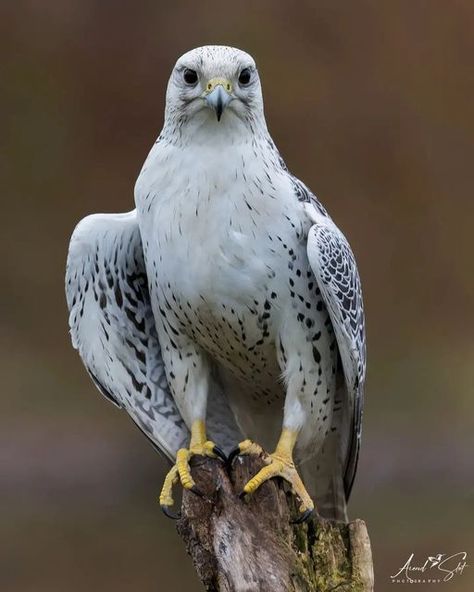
xmin=66 ymin=211 xmax=189 ymax=459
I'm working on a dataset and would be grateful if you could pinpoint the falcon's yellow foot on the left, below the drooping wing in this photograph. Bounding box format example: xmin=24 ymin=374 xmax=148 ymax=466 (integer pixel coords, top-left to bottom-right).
xmin=160 ymin=420 xmax=227 ymax=519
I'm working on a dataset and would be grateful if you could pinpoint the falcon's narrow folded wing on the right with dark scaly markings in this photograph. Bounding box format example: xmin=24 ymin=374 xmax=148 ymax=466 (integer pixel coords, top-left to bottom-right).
xmin=305 ymin=202 xmax=366 ymax=499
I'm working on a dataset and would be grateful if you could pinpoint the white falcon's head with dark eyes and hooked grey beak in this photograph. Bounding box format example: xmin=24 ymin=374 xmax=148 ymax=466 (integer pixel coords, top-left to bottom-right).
xmin=165 ymin=45 xmax=265 ymax=138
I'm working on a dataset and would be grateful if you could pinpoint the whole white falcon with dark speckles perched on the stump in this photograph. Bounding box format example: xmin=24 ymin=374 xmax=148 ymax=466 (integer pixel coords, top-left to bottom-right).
xmin=66 ymin=46 xmax=366 ymax=519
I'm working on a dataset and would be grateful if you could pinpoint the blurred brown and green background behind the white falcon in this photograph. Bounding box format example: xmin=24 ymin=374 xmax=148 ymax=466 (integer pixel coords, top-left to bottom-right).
xmin=0 ymin=0 xmax=474 ymax=592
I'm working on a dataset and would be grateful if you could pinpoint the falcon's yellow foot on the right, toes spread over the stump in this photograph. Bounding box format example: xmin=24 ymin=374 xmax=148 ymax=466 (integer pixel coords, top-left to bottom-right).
xmin=229 ymin=427 xmax=314 ymax=522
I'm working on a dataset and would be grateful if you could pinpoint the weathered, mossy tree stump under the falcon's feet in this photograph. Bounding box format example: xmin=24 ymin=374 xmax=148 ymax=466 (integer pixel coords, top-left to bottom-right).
xmin=177 ymin=456 xmax=374 ymax=592
